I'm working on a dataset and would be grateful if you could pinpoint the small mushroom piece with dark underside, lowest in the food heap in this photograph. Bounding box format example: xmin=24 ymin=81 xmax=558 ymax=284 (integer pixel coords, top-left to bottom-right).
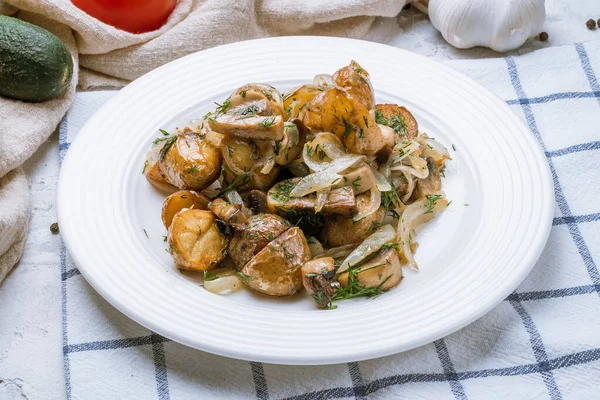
xmin=301 ymin=257 xmax=335 ymax=309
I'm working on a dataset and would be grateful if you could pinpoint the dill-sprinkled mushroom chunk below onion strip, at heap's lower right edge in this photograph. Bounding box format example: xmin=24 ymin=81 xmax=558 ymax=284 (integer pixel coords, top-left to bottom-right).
xmin=338 ymin=248 xmax=402 ymax=290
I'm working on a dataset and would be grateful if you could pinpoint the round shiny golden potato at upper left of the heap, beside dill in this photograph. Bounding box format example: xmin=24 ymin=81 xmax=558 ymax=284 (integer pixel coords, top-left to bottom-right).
xmin=159 ymin=132 xmax=221 ymax=190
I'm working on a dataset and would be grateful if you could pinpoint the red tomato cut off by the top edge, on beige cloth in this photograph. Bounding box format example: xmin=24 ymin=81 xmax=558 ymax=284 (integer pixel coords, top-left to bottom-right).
xmin=73 ymin=0 xmax=177 ymax=33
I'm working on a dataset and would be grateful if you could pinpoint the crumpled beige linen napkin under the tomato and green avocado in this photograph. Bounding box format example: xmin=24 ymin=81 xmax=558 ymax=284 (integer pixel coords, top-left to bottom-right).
xmin=0 ymin=0 xmax=407 ymax=282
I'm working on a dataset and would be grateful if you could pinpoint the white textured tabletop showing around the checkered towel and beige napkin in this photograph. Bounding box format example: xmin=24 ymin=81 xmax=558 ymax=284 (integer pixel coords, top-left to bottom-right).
xmin=0 ymin=0 xmax=600 ymax=400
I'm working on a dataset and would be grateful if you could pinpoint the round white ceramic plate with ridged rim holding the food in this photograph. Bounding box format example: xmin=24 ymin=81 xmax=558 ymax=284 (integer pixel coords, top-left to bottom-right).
xmin=58 ymin=37 xmax=553 ymax=364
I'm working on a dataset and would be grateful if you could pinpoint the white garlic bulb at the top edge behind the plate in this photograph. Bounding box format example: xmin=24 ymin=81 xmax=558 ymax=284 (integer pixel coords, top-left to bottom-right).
xmin=429 ymin=0 xmax=546 ymax=52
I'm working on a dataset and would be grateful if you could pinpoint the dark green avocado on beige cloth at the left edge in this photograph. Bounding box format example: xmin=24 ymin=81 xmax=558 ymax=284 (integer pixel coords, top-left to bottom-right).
xmin=0 ymin=16 xmax=73 ymax=102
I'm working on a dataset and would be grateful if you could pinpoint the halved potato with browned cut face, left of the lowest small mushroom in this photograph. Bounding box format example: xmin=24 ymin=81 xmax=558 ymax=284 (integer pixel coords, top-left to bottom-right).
xmin=241 ymin=227 xmax=310 ymax=296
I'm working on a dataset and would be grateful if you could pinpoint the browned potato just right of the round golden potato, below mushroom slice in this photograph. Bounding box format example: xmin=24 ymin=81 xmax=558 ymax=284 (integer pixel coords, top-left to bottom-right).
xmin=220 ymin=136 xmax=280 ymax=191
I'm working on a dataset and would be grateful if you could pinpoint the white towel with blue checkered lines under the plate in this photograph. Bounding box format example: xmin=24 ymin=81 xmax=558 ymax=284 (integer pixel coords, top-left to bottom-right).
xmin=60 ymin=41 xmax=600 ymax=400
